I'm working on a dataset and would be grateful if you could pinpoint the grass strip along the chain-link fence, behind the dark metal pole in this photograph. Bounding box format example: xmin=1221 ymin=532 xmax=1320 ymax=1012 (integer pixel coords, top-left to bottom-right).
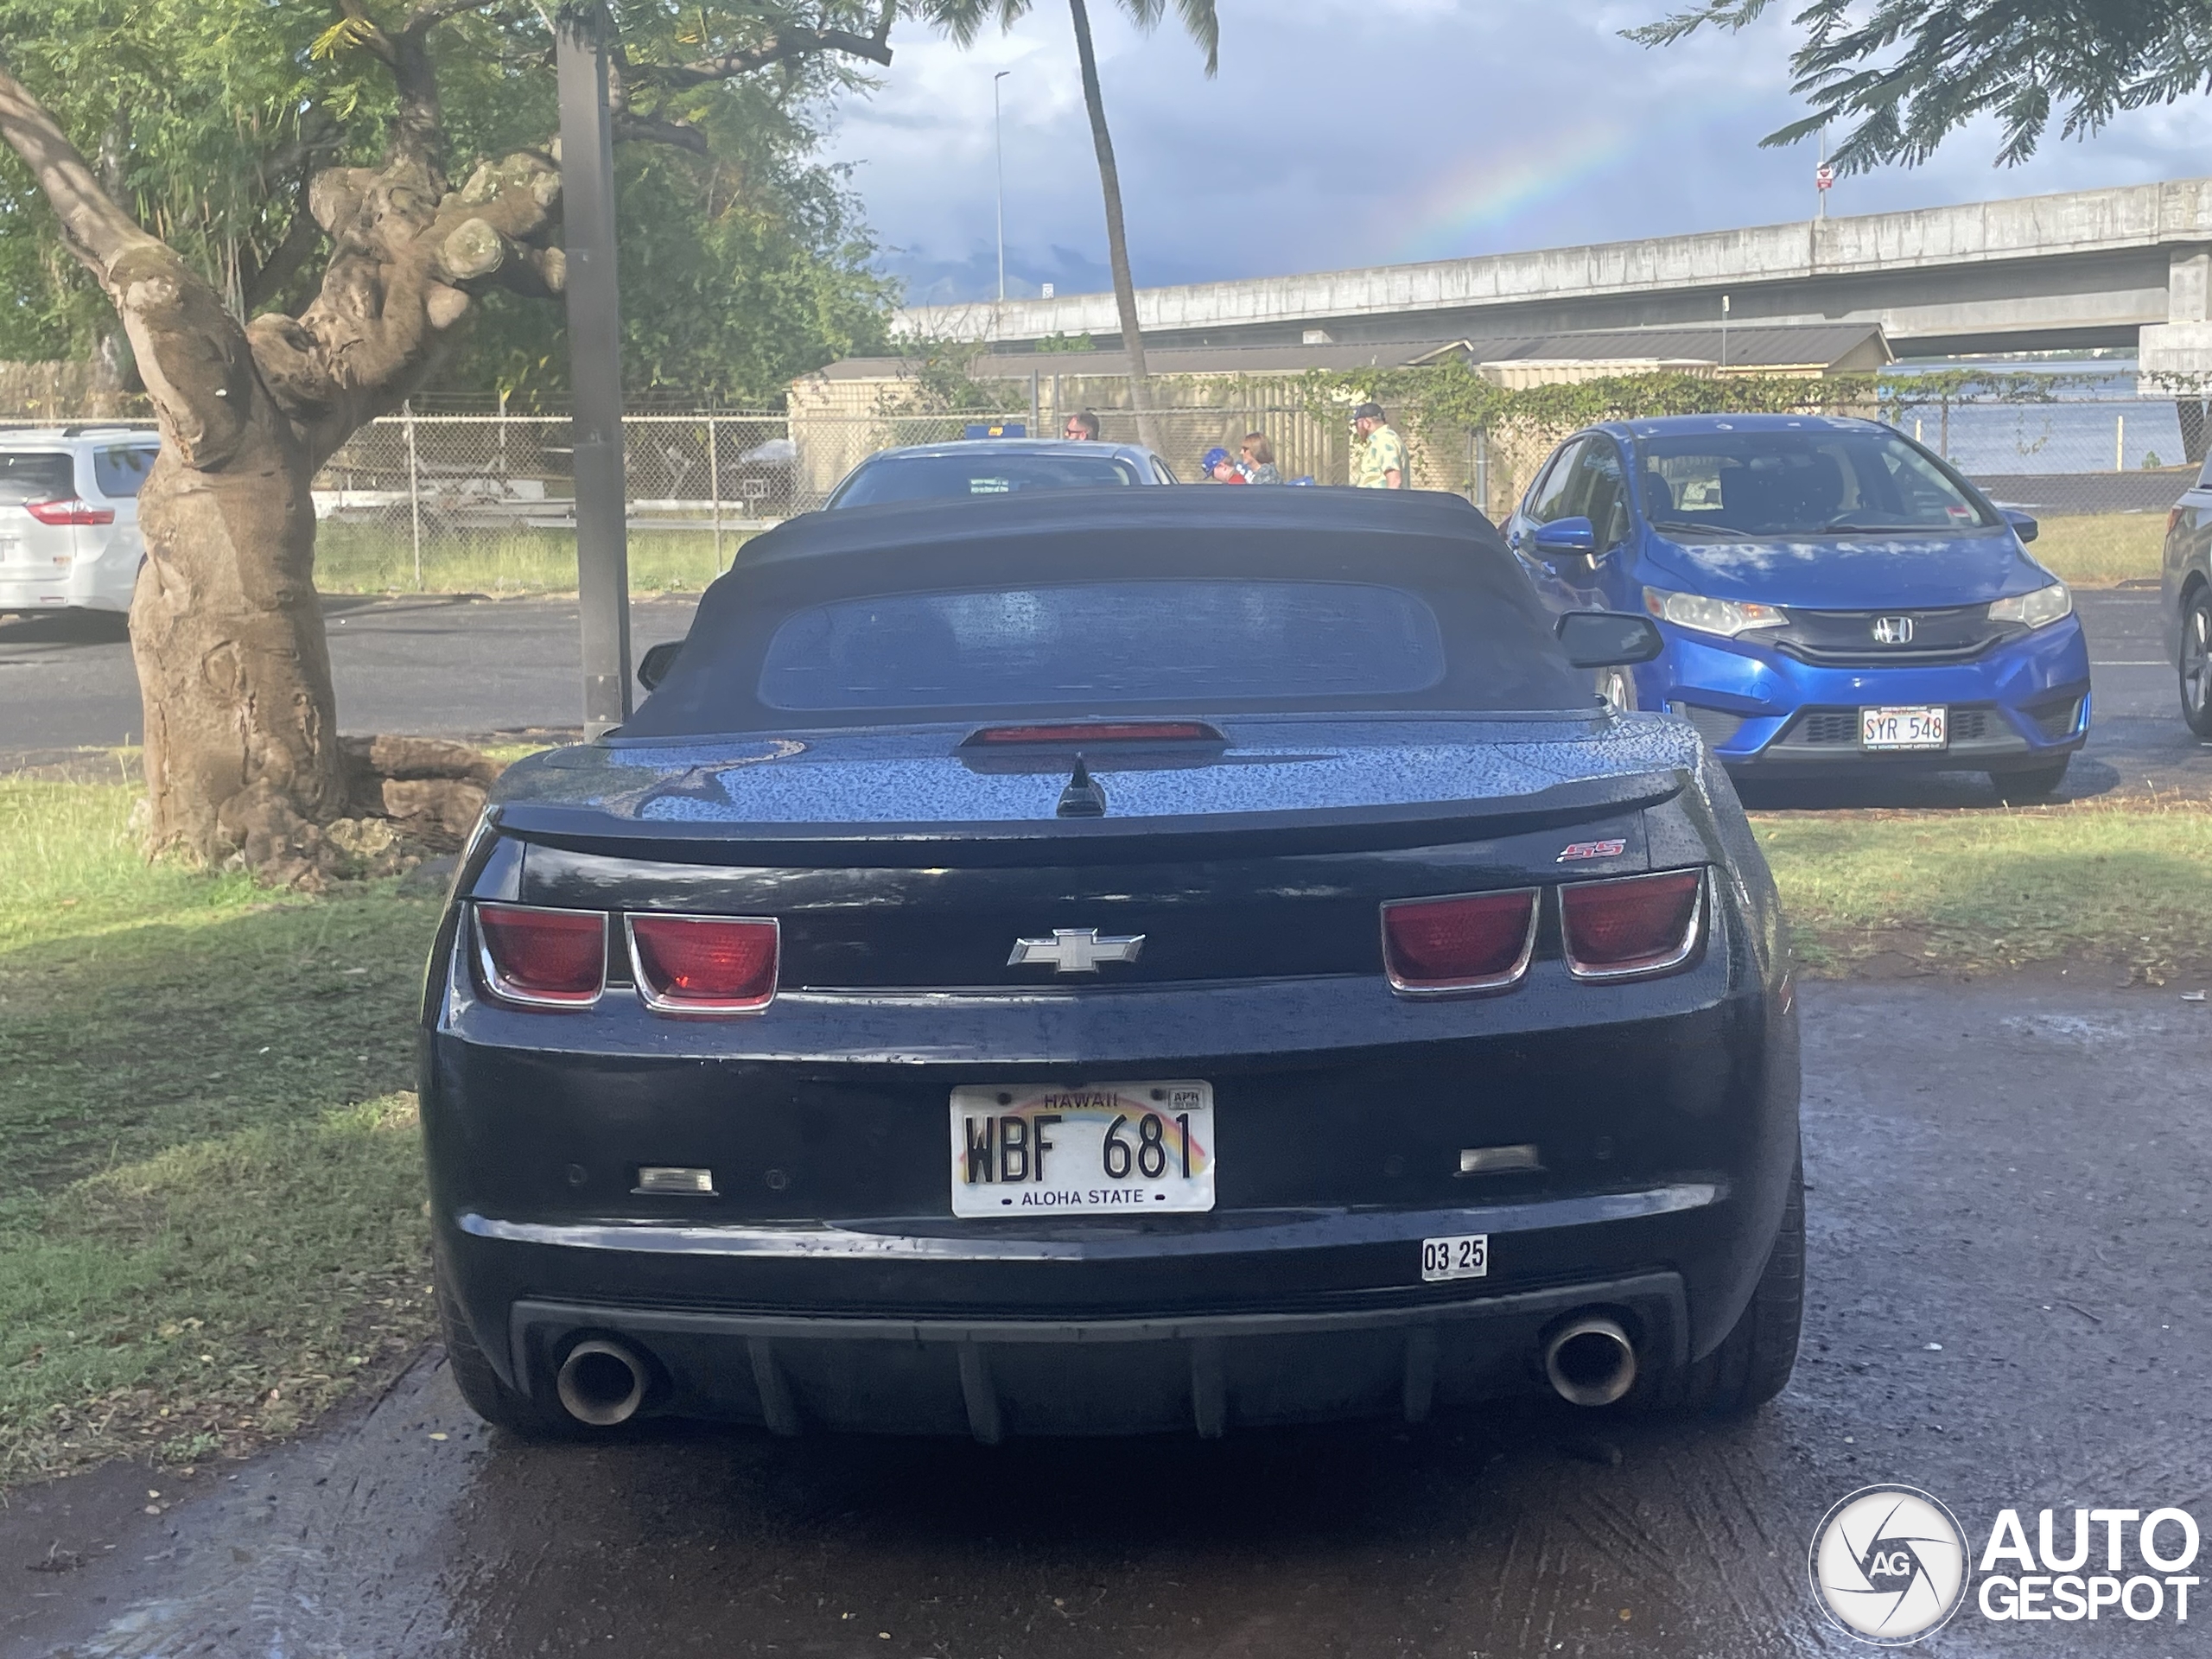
xmin=315 ymin=524 xmax=750 ymax=593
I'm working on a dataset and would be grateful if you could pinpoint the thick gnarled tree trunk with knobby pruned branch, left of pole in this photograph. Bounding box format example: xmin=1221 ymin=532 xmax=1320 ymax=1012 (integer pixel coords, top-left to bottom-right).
xmin=0 ymin=71 xmax=564 ymax=885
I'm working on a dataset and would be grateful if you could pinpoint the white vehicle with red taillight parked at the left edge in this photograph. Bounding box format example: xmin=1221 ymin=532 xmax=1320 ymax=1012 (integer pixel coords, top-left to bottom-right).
xmin=0 ymin=423 xmax=162 ymax=613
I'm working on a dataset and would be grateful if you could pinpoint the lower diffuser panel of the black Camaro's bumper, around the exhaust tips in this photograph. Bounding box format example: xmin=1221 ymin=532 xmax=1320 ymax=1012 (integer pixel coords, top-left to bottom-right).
xmin=509 ymin=1272 xmax=1688 ymax=1442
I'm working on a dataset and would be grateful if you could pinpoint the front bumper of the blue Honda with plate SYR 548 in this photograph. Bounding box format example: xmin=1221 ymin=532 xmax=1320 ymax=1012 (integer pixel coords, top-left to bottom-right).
xmin=1639 ymin=617 xmax=2090 ymax=772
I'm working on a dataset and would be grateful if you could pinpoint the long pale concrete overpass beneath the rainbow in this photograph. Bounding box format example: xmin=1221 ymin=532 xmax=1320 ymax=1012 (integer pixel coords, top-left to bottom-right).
xmin=900 ymin=179 xmax=2212 ymax=372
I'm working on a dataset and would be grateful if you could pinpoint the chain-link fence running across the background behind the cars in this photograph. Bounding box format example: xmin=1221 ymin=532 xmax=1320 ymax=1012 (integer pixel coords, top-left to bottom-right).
xmin=0 ymin=376 xmax=2212 ymax=593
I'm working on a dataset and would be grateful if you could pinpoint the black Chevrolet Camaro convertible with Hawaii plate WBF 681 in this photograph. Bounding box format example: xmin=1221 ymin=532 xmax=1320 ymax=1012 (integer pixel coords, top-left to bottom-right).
xmin=420 ymin=489 xmax=1805 ymax=1440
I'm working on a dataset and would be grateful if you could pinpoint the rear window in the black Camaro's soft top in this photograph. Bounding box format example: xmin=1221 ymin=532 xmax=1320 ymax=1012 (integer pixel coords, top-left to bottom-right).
xmin=759 ymin=580 xmax=1445 ymax=712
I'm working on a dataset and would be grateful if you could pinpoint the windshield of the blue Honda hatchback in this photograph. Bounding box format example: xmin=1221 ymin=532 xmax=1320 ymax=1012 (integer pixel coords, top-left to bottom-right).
xmin=1637 ymin=427 xmax=1998 ymax=537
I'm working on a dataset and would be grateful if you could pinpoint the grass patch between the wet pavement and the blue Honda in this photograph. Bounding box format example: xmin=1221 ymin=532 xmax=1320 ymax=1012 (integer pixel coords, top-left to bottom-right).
xmin=1752 ymin=803 xmax=2212 ymax=984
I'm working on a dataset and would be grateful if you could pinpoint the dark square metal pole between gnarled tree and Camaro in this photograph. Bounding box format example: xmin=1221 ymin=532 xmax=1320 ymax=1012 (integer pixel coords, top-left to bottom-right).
xmin=556 ymin=0 xmax=631 ymax=741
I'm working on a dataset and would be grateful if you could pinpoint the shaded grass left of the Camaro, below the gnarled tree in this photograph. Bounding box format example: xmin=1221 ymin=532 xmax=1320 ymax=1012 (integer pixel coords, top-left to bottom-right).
xmin=0 ymin=779 xmax=435 ymax=1484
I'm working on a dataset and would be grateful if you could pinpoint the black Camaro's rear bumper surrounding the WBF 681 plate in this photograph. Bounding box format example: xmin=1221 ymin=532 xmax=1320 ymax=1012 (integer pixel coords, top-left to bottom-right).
xmin=420 ymin=836 xmax=1798 ymax=1438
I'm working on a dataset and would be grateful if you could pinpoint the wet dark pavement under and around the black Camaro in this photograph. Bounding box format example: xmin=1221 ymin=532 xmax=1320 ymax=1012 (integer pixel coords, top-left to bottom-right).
xmin=0 ymin=973 xmax=2212 ymax=1659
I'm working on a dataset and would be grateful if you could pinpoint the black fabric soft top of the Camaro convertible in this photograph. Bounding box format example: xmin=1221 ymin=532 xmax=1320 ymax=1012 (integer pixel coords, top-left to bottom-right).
xmin=617 ymin=486 xmax=1591 ymax=741
